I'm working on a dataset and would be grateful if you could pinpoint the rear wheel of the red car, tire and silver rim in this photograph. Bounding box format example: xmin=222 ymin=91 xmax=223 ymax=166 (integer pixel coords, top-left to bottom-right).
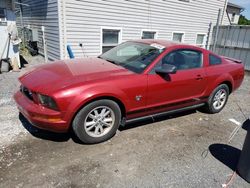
xmin=203 ymin=84 xmax=229 ymax=114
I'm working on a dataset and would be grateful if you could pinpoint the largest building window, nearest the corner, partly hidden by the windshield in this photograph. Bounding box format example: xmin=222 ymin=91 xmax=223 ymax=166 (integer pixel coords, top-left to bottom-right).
xmin=102 ymin=29 xmax=121 ymax=53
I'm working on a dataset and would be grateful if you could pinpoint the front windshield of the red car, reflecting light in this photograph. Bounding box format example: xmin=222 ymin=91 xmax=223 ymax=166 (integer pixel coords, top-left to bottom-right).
xmin=99 ymin=42 xmax=164 ymax=73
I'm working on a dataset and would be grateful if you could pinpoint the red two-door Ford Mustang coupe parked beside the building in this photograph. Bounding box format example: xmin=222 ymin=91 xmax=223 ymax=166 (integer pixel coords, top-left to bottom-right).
xmin=14 ymin=40 xmax=244 ymax=143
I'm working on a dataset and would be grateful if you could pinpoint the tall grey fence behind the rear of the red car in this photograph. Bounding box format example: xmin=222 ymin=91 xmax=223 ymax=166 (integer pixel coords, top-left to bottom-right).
xmin=211 ymin=25 xmax=250 ymax=71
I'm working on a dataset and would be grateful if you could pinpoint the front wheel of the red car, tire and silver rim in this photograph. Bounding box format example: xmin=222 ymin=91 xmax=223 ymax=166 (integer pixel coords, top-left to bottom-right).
xmin=72 ymin=99 xmax=121 ymax=144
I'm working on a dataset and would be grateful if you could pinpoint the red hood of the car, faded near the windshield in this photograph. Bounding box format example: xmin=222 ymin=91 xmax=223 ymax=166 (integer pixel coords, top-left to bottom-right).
xmin=19 ymin=58 xmax=134 ymax=94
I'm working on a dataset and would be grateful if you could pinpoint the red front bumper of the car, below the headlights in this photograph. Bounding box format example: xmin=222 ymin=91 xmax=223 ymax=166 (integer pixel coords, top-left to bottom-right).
xmin=14 ymin=91 xmax=69 ymax=133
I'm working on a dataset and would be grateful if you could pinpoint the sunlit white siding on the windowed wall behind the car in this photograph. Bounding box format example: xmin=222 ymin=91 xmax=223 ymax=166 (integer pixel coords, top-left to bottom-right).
xmin=60 ymin=0 xmax=229 ymax=57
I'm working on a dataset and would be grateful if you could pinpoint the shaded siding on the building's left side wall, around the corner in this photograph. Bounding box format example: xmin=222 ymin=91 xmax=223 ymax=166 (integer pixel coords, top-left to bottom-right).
xmin=16 ymin=0 xmax=60 ymax=60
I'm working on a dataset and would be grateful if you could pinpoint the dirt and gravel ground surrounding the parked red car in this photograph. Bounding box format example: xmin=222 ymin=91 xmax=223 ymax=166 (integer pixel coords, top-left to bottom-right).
xmin=0 ymin=56 xmax=250 ymax=188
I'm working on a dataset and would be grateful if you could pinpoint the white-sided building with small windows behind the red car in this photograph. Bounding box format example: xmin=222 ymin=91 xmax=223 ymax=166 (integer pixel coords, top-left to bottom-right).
xmin=15 ymin=0 xmax=234 ymax=60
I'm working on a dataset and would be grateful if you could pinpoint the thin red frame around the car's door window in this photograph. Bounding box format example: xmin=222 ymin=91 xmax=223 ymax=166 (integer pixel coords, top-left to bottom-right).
xmin=149 ymin=48 xmax=205 ymax=74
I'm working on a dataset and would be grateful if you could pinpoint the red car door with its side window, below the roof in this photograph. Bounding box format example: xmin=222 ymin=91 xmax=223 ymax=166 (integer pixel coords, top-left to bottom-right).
xmin=147 ymin=49 xmax=206 ymax=113
